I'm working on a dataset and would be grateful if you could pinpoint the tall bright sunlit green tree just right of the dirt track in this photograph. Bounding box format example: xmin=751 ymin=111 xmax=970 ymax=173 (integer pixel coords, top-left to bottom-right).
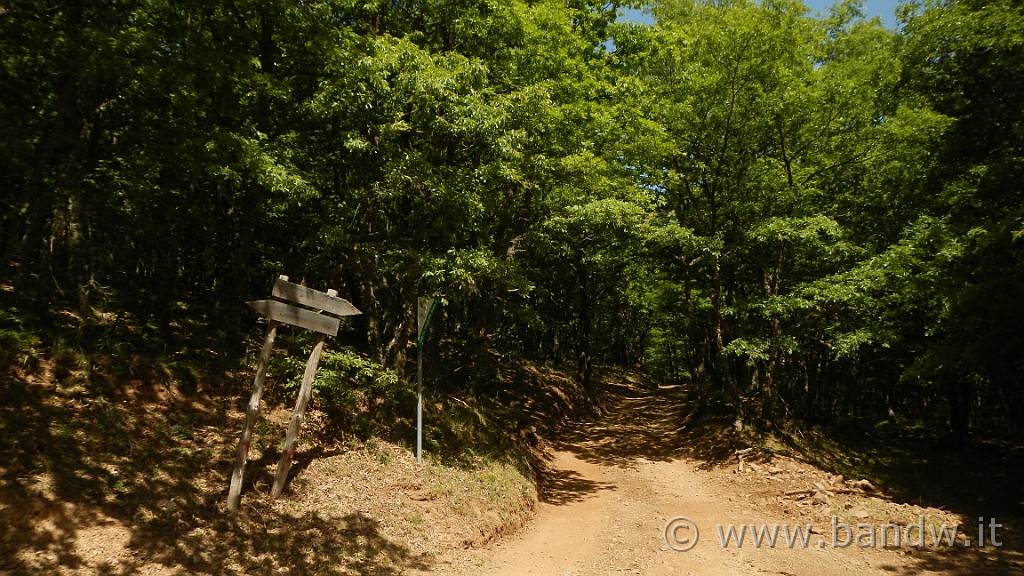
xmin=616 ymin=1 xmax=941 ymax=423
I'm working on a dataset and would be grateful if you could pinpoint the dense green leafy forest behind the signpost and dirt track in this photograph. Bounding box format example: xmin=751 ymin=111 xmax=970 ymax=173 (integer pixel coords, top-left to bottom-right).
xmin=0 ymin=0 xmax=1024 ymax=442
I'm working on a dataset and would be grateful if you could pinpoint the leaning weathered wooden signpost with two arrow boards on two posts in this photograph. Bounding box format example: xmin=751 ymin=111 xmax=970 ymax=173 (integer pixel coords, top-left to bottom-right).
xmin=227 ymin=276 xmax=362 ymax=511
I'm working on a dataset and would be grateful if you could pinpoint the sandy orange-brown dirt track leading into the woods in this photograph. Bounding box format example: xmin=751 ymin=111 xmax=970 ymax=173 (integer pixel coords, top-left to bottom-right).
xmin=438 ymin=381 xmax=1020 ymax=576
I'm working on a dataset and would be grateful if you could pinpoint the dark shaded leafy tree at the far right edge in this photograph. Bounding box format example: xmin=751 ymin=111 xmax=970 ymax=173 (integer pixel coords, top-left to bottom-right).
xmin=902 ymin=2 xmax=1024 ymax=432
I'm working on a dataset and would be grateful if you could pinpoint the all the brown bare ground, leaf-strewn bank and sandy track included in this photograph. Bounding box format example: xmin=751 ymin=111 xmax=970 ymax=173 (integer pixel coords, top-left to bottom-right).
xmin=0 ymin=356 xmax=1024 ymax=576
